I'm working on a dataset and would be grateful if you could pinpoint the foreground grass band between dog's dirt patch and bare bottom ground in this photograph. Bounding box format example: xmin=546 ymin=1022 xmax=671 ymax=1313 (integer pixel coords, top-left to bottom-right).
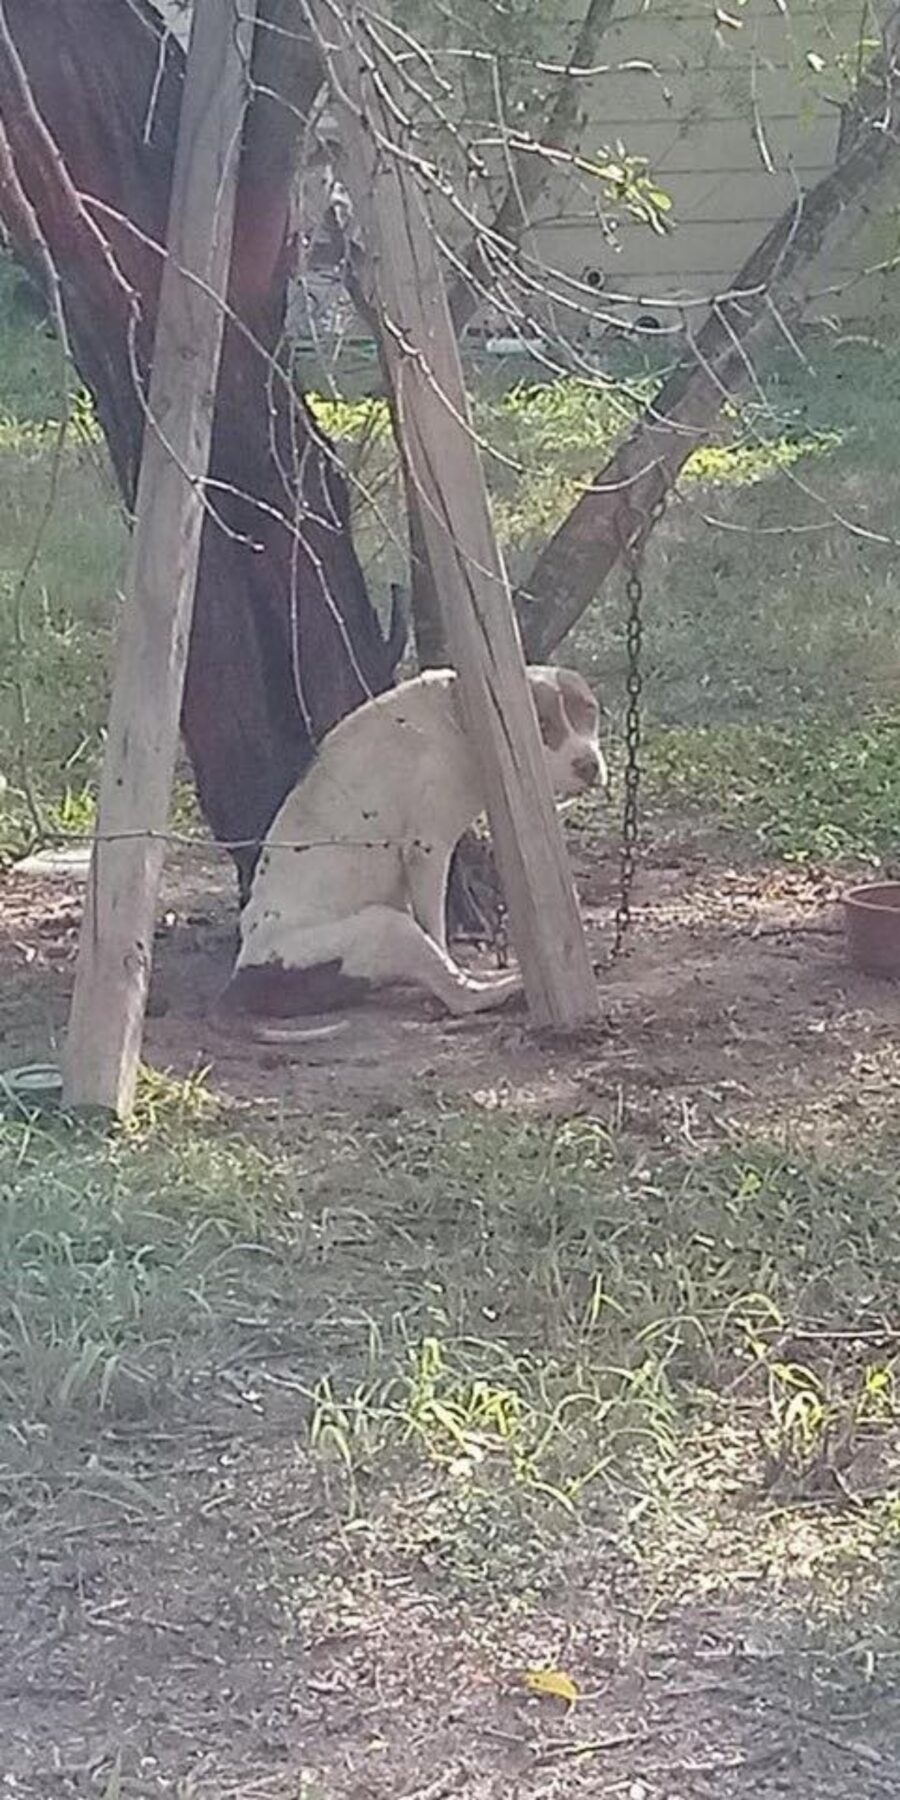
xmin=0 ymin=1080 xmax=900 ymax=1604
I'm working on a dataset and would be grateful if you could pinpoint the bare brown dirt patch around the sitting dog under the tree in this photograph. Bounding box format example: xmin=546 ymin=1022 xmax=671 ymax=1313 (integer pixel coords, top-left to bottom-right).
xmin=0 ymin=824 xmax=900 ymax=1136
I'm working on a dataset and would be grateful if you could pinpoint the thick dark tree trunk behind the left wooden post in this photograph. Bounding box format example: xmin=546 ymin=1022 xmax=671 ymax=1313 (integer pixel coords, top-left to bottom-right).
xmin=0 ymin=0 xmax=392 ymax=892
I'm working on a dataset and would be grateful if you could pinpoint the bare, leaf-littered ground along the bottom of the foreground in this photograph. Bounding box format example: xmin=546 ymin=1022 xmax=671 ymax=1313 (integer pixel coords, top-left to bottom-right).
xmin=7 ymin=1447 xmax=900 ymax=1800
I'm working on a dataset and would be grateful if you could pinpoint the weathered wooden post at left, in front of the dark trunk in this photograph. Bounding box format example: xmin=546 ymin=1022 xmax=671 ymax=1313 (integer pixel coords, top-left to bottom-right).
xmin=63 ymin=0 xmax=256 ymax=1116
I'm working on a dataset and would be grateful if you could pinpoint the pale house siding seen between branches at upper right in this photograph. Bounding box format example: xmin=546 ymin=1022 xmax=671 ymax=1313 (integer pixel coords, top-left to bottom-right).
xmin=529 ymin=0 xmax=893 ymax=322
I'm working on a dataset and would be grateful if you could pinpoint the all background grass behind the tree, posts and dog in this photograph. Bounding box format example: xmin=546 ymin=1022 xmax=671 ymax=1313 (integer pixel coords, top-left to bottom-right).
xmin=0 ymin=274 xmax=900 ymax=860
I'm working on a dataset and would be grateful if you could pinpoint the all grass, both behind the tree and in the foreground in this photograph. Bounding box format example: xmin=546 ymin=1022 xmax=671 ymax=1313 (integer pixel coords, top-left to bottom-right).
xmin=0 ymin=257 xmax=900 ymax=1785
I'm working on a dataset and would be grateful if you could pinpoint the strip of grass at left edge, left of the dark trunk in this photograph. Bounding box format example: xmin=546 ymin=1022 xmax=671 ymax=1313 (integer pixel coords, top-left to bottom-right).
xmin=0 ymin=265 xmax=126 ymax=857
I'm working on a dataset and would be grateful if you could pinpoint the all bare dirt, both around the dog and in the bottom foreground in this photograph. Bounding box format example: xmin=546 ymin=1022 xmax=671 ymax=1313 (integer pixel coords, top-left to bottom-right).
xmin=0 ymin=837 xmax=900 ymax=1800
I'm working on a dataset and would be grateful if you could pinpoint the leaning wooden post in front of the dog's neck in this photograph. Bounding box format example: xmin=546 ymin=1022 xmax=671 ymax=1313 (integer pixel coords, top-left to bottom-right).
xmin=306 ymin=0 xmax=598 ymax=1031
